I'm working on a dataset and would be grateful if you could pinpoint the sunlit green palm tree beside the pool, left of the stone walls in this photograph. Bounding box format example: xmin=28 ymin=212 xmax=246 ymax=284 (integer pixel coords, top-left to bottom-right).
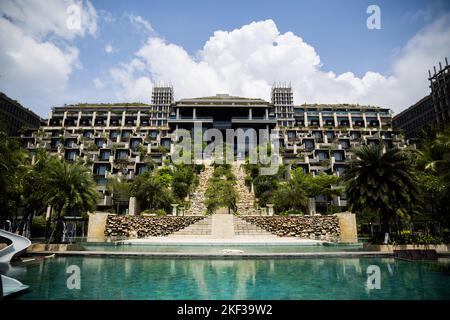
xmin=42 ymin=159 xmax=99 ymax=243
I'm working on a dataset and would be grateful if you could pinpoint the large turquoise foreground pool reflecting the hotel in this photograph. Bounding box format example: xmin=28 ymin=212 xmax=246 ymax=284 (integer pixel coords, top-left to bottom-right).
xmin=7 ymin=256 xmax=450 ymax=300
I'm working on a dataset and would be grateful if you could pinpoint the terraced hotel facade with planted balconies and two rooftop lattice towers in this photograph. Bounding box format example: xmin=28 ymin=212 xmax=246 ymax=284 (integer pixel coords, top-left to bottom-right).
xmin=22 ymin=86 xmax=407 ymax=212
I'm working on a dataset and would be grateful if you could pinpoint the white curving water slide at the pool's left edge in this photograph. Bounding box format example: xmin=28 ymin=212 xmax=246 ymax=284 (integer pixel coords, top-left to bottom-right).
xmin=0 ymin=229 xmax=31 ymax=298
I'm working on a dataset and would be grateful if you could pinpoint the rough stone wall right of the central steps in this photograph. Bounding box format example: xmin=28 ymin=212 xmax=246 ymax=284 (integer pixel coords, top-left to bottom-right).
xmin=241 ymin=216 xmax=340 ymax=242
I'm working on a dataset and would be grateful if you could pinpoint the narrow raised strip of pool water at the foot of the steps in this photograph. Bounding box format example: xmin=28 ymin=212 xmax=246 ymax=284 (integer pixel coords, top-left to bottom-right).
xmin=82 ymin=243 xmax=362 ymax=254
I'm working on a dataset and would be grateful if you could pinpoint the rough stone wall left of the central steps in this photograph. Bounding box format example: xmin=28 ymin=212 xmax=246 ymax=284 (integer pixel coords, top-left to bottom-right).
xmin=104 ymin=215 xmax=204 ymax=238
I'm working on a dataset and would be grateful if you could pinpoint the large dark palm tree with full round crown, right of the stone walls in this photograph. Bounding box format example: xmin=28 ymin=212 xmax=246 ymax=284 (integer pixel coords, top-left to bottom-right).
xmin=343 ymin=144 xmax=417 ymax=240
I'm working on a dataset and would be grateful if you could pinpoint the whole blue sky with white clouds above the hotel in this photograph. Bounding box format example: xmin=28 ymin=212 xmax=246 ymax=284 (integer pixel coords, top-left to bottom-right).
xmin=0 ymin=0 xmax=450 ymax=117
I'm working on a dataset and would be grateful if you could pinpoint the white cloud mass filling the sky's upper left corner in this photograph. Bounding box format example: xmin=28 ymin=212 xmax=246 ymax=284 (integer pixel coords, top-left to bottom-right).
xmin=0 ymin=0 xmax=97 ymax=115
